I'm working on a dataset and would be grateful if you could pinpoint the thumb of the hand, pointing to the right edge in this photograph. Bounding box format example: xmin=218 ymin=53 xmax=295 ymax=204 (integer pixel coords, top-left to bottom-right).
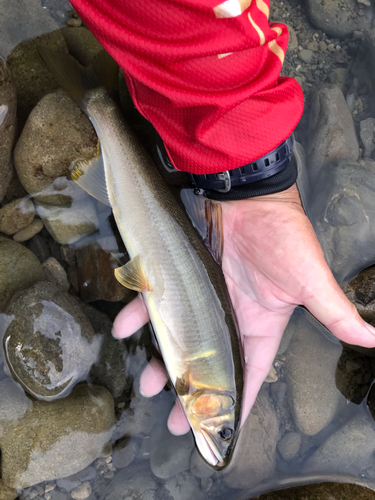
xmin=303 ymin=255 xmax=375 ymax=347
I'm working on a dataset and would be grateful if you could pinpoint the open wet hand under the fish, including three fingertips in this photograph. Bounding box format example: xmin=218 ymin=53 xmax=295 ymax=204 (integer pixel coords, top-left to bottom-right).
xmin=113 ymin=185 xmax=375 ymax=434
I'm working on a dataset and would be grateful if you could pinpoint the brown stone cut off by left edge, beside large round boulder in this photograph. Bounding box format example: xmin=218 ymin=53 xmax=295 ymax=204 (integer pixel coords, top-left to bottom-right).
xmin=0 ymin=60 xmax=17 ymax=202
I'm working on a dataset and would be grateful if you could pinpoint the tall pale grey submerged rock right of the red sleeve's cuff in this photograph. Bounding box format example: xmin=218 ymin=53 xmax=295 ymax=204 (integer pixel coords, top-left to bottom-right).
xmin=306 ymin=85 xmax=359 ymax=187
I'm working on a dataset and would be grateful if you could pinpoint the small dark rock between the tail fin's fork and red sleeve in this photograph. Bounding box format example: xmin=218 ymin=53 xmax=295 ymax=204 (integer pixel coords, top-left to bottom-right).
xmin=61 ymin=27 xmax=103 ymax=66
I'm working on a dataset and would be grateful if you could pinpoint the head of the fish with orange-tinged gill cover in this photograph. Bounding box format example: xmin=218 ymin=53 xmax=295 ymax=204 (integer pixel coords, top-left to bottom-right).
xmin=187 ymin=391 xmax=239 ymax=469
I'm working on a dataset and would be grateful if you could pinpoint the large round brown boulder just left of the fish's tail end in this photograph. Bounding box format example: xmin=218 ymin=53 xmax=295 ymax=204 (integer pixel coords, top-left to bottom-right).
xmin=14 ymin=90 xmax=97 ymax=205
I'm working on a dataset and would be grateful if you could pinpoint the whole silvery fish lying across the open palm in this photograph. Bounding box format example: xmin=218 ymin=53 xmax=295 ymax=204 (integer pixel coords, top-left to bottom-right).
xmin=38 ymin=47 xmax=244 ymax=470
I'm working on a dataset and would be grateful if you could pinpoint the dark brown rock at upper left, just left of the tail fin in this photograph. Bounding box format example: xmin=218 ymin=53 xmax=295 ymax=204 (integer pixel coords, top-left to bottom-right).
xmin=7 ymin=30 xmax=68 ymax=124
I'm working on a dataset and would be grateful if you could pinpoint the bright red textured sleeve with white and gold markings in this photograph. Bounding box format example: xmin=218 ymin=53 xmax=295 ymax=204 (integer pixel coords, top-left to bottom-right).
xmin=67 ymin=0 xmax=303 ymax=174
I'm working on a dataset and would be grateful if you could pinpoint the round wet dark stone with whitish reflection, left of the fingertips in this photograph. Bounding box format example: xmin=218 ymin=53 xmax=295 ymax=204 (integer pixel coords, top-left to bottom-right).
xmin=4 ymin=281 xmax=101 ymax=401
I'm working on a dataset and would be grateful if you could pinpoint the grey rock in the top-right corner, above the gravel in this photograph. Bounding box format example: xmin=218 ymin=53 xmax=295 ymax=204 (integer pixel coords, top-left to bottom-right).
xmin=307 ymin=0 xmax=372 ymax=38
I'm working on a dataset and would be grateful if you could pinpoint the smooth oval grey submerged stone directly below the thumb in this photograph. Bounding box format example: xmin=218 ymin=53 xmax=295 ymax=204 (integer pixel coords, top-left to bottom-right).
xmin=284 ymin=314 xmax=345 ymax=435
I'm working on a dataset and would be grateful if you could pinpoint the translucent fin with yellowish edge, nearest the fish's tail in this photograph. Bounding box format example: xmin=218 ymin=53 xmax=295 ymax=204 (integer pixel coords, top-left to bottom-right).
xmin=71 ymin=146 xmax=111 ymax=206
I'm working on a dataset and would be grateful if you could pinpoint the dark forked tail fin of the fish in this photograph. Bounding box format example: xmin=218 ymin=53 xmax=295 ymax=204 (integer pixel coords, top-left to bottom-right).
xmin=38 ymin=46 xmax=118 ymax=108
